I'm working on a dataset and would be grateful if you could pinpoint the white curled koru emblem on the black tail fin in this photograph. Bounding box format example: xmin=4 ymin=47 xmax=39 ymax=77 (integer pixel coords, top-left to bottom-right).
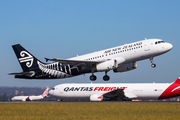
xmin=19 ymin=51 xmax=34 ymax=67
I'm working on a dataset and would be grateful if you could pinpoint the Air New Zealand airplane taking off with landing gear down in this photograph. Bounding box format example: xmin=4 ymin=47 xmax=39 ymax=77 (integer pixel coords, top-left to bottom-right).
xmin=9 ymin=39 xmax=173 ymax=81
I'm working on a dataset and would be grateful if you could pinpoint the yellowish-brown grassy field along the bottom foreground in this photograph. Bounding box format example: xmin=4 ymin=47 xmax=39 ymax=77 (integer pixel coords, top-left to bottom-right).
xmin=0 ymin=102 xmax=180 ymax=120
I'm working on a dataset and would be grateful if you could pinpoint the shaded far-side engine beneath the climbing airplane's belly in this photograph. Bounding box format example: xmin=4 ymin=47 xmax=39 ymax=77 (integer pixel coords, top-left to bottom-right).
xmin=113 ymin=62 xmax=137 ymax=73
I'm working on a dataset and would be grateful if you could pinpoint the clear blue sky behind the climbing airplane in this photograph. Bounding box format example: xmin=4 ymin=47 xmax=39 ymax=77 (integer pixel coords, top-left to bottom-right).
xmin=0 ymin=0 xmax=180 ymax=87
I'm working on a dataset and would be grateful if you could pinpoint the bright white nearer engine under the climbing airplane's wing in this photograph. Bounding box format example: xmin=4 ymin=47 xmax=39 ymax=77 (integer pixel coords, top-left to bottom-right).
xmin=96 ymin=57 xmax=125 ymax=72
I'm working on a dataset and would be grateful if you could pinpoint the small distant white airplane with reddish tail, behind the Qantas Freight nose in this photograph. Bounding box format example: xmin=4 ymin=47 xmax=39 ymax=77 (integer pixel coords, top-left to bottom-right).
xmin=11 ymin=88 xmax=50 ymax=101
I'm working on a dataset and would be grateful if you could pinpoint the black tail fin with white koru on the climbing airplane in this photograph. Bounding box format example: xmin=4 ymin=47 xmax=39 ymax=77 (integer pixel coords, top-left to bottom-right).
xmin=12 ymin=44 xmax=43 ymax=72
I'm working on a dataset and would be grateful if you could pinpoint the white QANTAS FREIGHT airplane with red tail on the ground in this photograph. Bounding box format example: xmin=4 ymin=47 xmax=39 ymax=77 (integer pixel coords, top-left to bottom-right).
xmin=49 ymin=77 xmax=180 ymax=101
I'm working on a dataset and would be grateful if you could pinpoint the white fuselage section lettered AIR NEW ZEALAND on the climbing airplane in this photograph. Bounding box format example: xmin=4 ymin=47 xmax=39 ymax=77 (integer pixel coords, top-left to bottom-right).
xmin=69 ymin=39 xmax=172 ymax=63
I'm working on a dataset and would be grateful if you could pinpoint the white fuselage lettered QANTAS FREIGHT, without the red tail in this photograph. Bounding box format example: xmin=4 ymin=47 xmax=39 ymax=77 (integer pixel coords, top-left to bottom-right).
xmin=49 ymin=83 xmax=170 ymax=100
